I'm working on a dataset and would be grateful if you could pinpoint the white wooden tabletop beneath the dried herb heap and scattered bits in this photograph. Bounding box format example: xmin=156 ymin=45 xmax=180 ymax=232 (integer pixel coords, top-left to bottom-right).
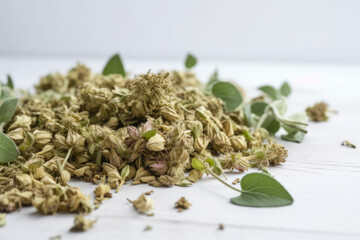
xmin=0 ymin=56 xmax=360 ymax=240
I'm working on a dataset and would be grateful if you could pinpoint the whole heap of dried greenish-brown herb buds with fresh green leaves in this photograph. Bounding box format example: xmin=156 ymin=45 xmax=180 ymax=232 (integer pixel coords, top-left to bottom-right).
xmin=0 ymin=55 xmax=307 ymax=220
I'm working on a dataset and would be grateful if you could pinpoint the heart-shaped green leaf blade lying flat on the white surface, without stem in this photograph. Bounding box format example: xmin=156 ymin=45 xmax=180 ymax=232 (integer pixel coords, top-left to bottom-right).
xmin=231 ymin=173 xmax=294 ymax=207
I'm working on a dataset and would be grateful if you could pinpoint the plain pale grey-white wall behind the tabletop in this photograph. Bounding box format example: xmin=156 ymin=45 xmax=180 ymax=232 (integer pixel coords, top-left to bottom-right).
xmin=0 ymin=0 xmax=360 ymax=62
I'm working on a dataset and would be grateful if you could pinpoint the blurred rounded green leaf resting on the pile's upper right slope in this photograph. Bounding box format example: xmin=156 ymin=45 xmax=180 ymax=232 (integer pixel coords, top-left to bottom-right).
xmin=212 ymin=82 xmax=243 ymax=112
